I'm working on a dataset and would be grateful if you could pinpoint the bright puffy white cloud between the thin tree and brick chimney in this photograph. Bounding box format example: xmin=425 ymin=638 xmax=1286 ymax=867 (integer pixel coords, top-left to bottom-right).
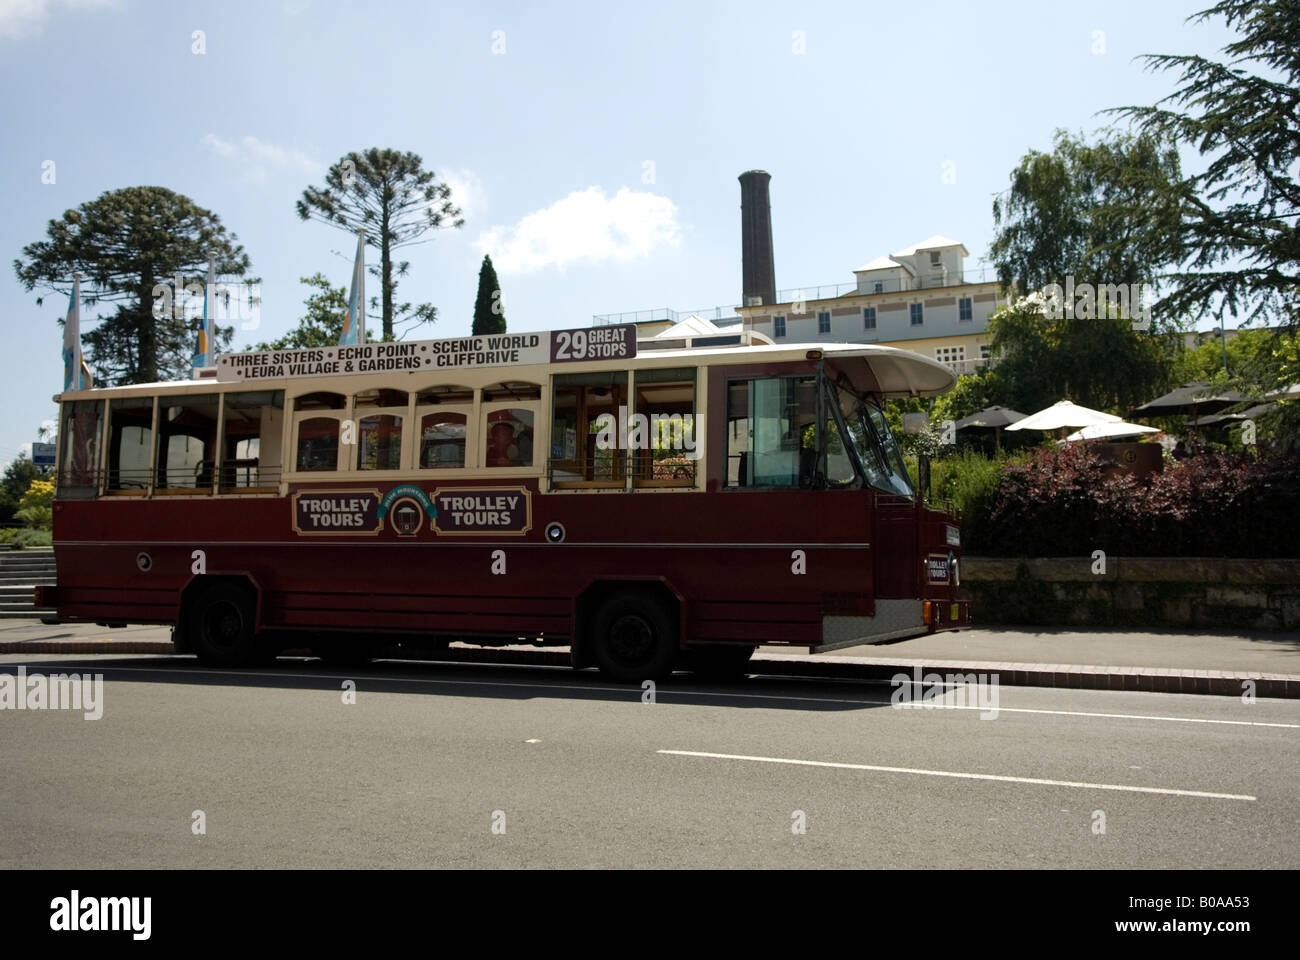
xmin=476 ymin=187 xmax=681 ymax=273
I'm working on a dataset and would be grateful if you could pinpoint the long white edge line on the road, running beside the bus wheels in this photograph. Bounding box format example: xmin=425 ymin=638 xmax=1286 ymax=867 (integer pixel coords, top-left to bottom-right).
xmin=10 ymin=654 xmax=1300 ymax=730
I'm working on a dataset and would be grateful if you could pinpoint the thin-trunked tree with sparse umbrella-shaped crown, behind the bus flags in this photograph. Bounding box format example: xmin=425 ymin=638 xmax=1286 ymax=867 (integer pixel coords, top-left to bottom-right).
xmin=296 ymin=147 xmax=465 ymax=340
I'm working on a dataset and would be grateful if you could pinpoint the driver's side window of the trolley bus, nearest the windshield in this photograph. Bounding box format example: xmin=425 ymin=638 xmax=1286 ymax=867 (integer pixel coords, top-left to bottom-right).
xmin=727 ymin=376 xmax=816 ymax=487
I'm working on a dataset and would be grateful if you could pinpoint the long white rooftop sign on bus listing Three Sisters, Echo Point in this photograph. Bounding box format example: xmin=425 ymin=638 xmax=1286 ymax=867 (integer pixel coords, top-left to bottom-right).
xmin=217 ymin=324 xmax=637 ymax=382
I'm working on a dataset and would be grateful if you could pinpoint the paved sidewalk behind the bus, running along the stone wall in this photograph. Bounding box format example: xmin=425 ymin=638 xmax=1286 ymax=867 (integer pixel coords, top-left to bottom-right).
xmin=0 ymin=620 xmax=1300 ymax=699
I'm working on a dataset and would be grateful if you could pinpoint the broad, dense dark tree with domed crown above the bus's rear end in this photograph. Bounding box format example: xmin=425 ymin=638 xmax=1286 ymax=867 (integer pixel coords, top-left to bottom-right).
xmin=13 ymin=186 xmax=257 ymax=384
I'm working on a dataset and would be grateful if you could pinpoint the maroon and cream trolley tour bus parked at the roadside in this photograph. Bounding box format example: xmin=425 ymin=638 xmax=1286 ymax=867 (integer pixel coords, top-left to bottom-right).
xmin=38 ymin=327 xmax=970 ymax=680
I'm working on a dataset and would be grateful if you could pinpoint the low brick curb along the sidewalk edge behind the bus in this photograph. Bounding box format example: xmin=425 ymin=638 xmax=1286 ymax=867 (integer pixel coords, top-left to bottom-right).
xmin=0 ymin=640 xmax=1300 ymax=700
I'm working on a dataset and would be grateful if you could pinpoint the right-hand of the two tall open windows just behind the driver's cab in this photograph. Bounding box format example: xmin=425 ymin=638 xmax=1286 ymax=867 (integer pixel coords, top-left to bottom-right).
xmin=628 ymin=367 xmax=699 ymax=487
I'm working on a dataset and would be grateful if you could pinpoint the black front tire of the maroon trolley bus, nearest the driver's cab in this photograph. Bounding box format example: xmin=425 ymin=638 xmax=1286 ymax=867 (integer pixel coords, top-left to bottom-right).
xmin=592 ymin=591 xmax=679 ymax=683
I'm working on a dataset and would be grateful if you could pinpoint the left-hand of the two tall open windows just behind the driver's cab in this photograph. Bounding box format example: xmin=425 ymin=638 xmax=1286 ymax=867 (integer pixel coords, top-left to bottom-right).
xmin=549 ymin=371 xmax=628 ymax=487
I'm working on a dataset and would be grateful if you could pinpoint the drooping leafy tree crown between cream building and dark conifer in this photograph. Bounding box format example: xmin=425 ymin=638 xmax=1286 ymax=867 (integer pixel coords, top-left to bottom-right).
xmin=991 ymin=130 xmax=1187 ymax=295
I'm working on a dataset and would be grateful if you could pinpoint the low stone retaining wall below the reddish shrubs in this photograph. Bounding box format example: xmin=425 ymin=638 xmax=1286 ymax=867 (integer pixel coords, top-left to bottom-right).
xmin=961 ymin=557 xmax=1300 ymax=630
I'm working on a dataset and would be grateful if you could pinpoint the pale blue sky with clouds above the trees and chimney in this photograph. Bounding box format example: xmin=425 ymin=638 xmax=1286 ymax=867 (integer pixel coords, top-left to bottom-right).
xmin=0 ymin=0 xmax=1229 ymax=464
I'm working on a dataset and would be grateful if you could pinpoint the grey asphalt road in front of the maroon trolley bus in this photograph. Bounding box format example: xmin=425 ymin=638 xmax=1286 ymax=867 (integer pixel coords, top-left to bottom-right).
xmin=0 ymin=656 xmax=1300 ymax=869
